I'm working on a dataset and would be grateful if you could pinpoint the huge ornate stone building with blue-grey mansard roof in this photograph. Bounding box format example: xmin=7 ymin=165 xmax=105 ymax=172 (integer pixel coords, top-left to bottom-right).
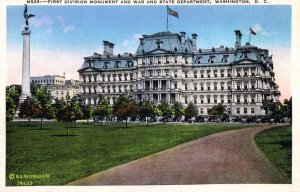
xmin=78 ymin=30 xmax=280 ymax=116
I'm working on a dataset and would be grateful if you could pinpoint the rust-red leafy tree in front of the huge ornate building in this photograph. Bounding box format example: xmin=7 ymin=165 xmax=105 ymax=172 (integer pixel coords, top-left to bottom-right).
xmin=116 ymin=101 xmax=139 ymax=128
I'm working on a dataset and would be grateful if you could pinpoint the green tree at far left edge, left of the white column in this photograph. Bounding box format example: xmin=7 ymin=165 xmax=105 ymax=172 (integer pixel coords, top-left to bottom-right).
xmin=6 ymin=86 xmax=21 ymax=122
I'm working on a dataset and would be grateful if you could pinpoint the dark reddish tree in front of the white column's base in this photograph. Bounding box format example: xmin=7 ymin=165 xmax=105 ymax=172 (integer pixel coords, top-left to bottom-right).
xmin=19 ymin=97 xmax=41 ymax=125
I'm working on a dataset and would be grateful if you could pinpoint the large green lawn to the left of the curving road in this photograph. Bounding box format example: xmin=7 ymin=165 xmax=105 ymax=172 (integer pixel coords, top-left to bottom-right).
xmin=6 ymin=122 xmax=255 ymax=185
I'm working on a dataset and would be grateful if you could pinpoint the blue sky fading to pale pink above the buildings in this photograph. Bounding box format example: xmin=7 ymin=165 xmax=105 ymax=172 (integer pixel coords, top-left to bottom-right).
xmin=7 ymin=5 xmax=291 ymax=99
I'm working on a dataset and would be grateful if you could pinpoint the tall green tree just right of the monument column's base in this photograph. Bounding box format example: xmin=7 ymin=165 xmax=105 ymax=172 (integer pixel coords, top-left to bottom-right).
xmin=34 ymin=88 xmax=55 ymax=129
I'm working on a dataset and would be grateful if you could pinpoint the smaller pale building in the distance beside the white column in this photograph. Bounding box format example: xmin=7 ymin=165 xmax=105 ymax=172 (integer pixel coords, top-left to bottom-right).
xmin=30 ymin=75 xmax=79 ymax=99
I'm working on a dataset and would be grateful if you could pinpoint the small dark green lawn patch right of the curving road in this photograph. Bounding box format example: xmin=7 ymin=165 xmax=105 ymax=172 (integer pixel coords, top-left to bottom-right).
xmin=255 ymin=126 xmax=292 ymax=179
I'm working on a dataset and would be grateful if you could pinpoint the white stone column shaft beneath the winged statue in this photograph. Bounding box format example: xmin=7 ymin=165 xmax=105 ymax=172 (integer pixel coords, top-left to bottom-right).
xmin=20 ymin=30 xmax=31 ymax=103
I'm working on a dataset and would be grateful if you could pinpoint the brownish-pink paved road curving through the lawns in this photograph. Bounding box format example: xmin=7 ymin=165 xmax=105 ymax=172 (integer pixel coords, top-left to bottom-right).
xmin=68 ymin=125 xmax=288 ymax=185
